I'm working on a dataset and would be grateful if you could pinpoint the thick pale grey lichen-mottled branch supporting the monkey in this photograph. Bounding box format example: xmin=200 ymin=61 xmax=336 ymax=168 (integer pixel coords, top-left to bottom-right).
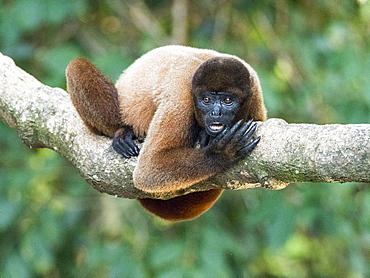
xmin=0 ymin=54 xmax=370 ymax=198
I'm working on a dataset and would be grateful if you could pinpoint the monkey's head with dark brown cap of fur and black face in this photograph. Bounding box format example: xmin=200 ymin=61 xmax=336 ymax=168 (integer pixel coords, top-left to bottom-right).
xmin=192 ymin=57 xmax=251 ymax=137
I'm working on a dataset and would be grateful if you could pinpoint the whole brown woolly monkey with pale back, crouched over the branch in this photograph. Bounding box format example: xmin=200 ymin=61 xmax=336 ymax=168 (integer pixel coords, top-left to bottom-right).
xmin=66 ymin=46 xmax=266 ymax=221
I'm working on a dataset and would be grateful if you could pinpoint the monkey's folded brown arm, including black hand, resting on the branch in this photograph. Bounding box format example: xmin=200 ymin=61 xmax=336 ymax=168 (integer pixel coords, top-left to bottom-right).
xmin=134 ymin=110 xmax=259 ymax=192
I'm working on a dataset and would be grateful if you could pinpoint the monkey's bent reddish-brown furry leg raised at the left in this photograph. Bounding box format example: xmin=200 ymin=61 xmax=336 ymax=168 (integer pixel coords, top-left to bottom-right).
xmin=66 ymin=58 xmax=122 ymax=137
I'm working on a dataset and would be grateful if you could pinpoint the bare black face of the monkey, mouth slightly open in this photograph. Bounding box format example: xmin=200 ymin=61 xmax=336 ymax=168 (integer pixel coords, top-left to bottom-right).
xmin=195 ymin=91 xmax=240 ymax=137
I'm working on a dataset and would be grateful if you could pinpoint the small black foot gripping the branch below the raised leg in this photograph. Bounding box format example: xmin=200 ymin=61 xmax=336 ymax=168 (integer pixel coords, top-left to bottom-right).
xmin=112 ymin=126 xmax=140 ymax=158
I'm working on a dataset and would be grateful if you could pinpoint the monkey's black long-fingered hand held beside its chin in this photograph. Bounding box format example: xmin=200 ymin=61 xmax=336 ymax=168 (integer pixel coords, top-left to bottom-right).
xmin=206 ymin=120 xmax=261 ymax=163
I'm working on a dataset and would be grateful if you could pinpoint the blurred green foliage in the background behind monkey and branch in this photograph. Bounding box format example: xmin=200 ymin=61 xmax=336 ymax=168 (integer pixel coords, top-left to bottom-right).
xmin=0 ymin=0 xmax=370 ymax=277
